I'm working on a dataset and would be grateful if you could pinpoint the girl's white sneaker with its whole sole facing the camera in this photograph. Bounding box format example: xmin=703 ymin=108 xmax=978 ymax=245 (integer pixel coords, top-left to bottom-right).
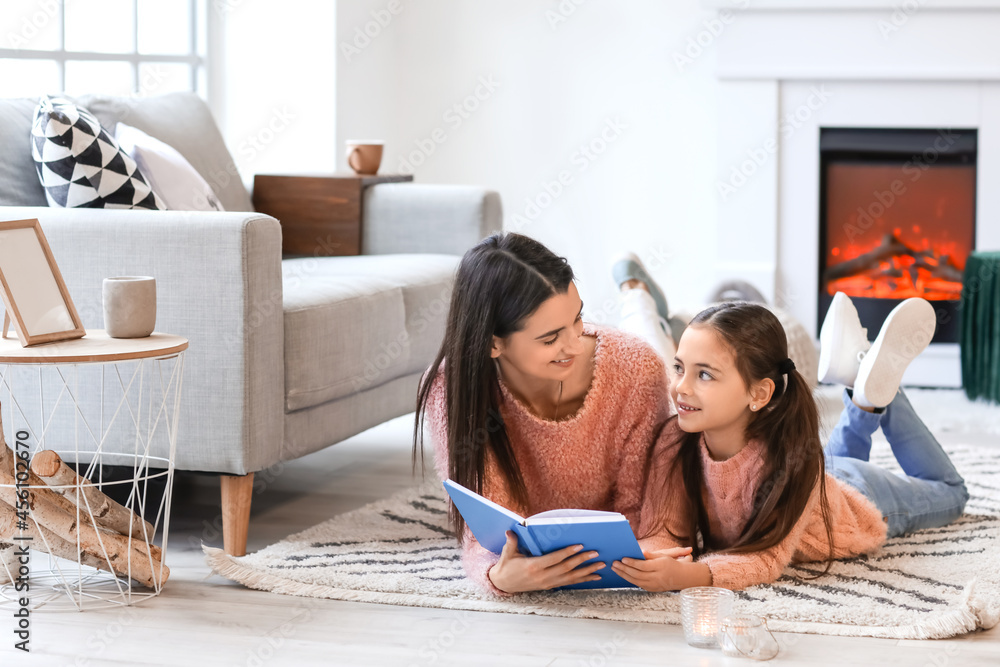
xmin=854 ymin=298 xmax=937 ymax=408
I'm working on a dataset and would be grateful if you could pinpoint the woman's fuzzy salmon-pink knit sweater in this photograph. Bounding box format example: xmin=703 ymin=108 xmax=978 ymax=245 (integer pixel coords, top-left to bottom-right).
xmin=426 ymin=324 xmax=669 ymax=595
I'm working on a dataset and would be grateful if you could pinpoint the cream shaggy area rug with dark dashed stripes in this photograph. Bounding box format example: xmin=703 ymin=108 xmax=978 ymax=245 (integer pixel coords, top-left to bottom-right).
xmin=205 ymin=446 xmax=1000 ymax=639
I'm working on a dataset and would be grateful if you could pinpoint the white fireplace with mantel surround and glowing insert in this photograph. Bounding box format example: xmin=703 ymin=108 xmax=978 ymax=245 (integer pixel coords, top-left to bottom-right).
xmin=702 ymin=0 xmax=1000 ymax=387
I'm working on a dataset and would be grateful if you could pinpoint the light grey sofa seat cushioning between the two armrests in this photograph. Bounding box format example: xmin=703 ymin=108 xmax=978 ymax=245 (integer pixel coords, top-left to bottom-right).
xmin=284 ymin=254 xmax=459 ymax=411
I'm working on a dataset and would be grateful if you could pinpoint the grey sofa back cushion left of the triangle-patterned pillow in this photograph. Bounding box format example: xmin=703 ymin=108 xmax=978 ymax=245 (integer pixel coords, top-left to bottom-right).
xmin=0 ymin=97 xmax=48 ymax=206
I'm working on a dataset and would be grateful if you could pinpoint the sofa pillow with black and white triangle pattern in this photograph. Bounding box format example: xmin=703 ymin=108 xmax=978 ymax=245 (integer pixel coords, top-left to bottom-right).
xmin=31 ymin=96 xmax=167 ymax=210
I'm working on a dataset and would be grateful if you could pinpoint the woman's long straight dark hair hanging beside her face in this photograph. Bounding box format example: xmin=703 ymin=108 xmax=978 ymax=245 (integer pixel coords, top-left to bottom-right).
xmin=413 ymin=233 xmax=573 ymax=537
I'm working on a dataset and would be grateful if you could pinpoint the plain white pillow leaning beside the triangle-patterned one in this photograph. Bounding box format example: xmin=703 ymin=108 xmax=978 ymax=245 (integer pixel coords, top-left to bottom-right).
xmin=115 ymin=123 xmax=224 ymax=211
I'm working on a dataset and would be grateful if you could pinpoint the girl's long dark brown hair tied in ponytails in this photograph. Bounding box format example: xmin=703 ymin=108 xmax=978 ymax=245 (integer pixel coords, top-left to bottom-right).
xmin=648 ymin=301 xmax=833 ymax=572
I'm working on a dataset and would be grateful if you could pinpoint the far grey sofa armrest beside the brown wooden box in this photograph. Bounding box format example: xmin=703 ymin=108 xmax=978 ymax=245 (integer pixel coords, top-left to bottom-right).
xmin=361 ymin=183 xmax=503 ymax=255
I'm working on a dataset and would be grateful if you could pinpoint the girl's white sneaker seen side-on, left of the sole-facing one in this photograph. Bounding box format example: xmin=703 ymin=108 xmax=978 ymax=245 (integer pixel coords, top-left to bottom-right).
xmin=819 ymin=292 xmax=871 ymax=387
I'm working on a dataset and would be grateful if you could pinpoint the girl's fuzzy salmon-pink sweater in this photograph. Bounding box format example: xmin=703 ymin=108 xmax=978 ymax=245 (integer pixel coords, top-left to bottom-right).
xmin=640 ymin=419 xmax=886 ymax=590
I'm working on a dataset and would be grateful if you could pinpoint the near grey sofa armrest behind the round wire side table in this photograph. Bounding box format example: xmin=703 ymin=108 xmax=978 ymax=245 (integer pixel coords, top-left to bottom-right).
xmin=0 ymin=207 xmax=284 ymax=474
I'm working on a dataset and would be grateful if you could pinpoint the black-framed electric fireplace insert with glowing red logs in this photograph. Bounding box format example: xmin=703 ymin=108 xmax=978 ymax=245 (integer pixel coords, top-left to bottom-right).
xmin=817 ymin=127 xmax=977 ymax=343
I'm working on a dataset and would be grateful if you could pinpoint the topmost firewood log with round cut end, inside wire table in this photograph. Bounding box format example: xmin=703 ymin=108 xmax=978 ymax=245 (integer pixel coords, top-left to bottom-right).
xmin=31 ymin=450 xmax=153 ymax=539
